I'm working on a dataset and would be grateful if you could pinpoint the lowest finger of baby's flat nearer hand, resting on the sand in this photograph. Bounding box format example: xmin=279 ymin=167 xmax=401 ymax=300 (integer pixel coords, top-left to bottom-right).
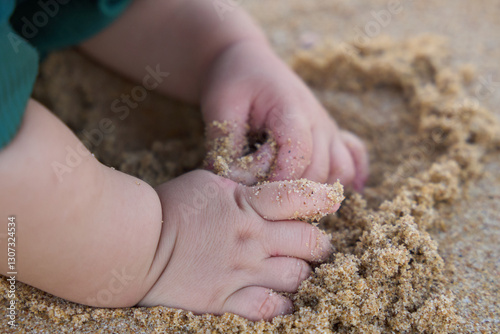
xmin=222 ymin=286 xmax=293 ymax=321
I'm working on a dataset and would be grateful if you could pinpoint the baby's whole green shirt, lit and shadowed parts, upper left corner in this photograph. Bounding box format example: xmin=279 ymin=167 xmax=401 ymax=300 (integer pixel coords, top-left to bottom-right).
xmin=0 ymin=0 xmax=131 ymax=149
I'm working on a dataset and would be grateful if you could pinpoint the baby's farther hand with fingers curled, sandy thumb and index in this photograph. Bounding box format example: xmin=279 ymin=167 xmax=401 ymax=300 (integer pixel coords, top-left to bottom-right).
xmin=202 ymin=42 xmax=368 ymax=190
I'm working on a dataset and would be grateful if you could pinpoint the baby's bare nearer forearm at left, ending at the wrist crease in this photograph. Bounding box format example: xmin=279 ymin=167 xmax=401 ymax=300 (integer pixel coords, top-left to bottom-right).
xmin=0 ymin=101 xmax=162 ymax=307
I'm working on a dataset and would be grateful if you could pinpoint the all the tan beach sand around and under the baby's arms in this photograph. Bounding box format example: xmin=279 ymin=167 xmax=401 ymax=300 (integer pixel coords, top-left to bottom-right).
xmin=0 ymin=1 xmax=500 ymax=333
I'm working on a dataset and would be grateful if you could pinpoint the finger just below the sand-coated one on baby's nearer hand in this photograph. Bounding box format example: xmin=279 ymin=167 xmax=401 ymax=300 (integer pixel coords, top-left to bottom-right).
xmin=262 ymin=221 xmax=333 ymax=262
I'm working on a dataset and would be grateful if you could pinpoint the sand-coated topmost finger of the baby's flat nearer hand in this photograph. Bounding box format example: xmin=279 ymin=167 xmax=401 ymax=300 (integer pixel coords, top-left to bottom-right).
xmin=241 ymin=179 xmax=344 ymax=221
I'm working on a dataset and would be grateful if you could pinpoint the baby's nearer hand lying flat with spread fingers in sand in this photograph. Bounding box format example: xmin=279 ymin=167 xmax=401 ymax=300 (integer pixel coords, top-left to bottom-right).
xmin=139 ymin=171 xmax=343 ymax=320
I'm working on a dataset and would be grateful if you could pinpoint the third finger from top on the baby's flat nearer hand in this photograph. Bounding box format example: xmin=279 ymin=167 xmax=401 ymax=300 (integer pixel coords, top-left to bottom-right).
xmin=253 ymin=257 xmax=311 ymax=292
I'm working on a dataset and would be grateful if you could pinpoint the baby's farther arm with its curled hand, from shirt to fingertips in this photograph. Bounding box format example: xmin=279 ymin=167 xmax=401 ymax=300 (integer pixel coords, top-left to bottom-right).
xmin=78 ymin=0 xmax=368 ymax=190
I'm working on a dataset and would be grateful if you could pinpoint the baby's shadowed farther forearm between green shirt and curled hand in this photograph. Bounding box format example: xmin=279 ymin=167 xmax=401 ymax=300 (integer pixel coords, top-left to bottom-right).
xmin=81 ymin=0 xmax=262 ymax=103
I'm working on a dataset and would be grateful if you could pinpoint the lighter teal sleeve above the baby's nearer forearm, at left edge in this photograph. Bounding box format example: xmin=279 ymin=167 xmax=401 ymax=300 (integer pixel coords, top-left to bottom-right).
xmin=0 ymin=0 xmax=38 ymax=149
